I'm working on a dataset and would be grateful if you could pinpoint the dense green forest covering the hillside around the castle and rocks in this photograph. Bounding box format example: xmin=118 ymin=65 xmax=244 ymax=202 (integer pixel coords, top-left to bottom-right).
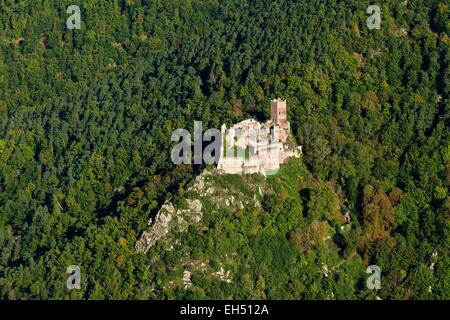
xmin=0 ymin=0 xmax=450 ymax=299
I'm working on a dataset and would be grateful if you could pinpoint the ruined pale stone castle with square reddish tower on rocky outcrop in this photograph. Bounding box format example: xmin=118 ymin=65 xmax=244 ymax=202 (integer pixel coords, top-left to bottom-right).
xmin=217 ymin=98 xmax=301 ymax=175
